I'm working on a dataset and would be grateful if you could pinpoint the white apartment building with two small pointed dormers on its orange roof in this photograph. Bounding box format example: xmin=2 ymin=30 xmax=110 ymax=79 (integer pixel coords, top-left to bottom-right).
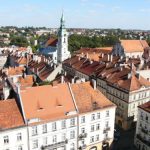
xmin=20 ymin=84 xmax=77 ymax=150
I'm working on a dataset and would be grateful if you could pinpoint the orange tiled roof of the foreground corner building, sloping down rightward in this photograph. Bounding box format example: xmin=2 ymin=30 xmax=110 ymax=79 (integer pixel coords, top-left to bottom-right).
xmin=71 ymin=82 xmax=115 ymax=113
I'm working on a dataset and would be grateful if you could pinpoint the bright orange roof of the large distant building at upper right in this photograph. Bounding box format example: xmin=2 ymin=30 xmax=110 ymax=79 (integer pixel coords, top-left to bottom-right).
xmin=120 ymin=40 xmax=149 ymax=52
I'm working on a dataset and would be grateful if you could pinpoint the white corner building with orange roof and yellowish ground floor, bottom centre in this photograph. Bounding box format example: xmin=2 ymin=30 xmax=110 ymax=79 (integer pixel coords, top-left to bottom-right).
xmin=71 ymin=82 xmax=116 ymax=150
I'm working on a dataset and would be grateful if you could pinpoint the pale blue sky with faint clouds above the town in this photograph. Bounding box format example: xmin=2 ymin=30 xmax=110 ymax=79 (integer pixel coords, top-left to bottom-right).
xmin=0 ymin=0 xmax=150 ymax=30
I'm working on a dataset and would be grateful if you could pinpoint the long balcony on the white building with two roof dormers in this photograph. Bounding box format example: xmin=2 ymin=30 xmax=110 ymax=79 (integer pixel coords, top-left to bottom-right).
xmin=41 ymin=139 xmax=68 ymax=150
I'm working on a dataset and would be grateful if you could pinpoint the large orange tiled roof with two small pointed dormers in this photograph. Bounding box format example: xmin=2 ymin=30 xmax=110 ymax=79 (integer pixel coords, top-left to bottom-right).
xmin=21 ymin=84 xmax=75 ymax=121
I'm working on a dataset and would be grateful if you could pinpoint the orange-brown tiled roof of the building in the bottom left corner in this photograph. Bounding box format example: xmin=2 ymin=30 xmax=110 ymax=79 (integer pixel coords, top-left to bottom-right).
xmin=0 ymin=99 xmax=24 ymax=130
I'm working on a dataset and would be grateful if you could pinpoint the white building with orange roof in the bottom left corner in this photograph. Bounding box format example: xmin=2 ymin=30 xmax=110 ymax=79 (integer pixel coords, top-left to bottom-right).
xmin=0 ymin=99 xmax=28 ymax=150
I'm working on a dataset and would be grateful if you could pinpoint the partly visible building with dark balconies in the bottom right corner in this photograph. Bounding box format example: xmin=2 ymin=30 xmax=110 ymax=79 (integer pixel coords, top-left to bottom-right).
xmin=134 ymin=101 xmax=150 ymax=150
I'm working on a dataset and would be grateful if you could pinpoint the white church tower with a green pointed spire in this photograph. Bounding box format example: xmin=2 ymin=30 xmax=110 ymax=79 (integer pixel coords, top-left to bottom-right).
xmin=57 ymin=14 xmax=71 ymax=63
